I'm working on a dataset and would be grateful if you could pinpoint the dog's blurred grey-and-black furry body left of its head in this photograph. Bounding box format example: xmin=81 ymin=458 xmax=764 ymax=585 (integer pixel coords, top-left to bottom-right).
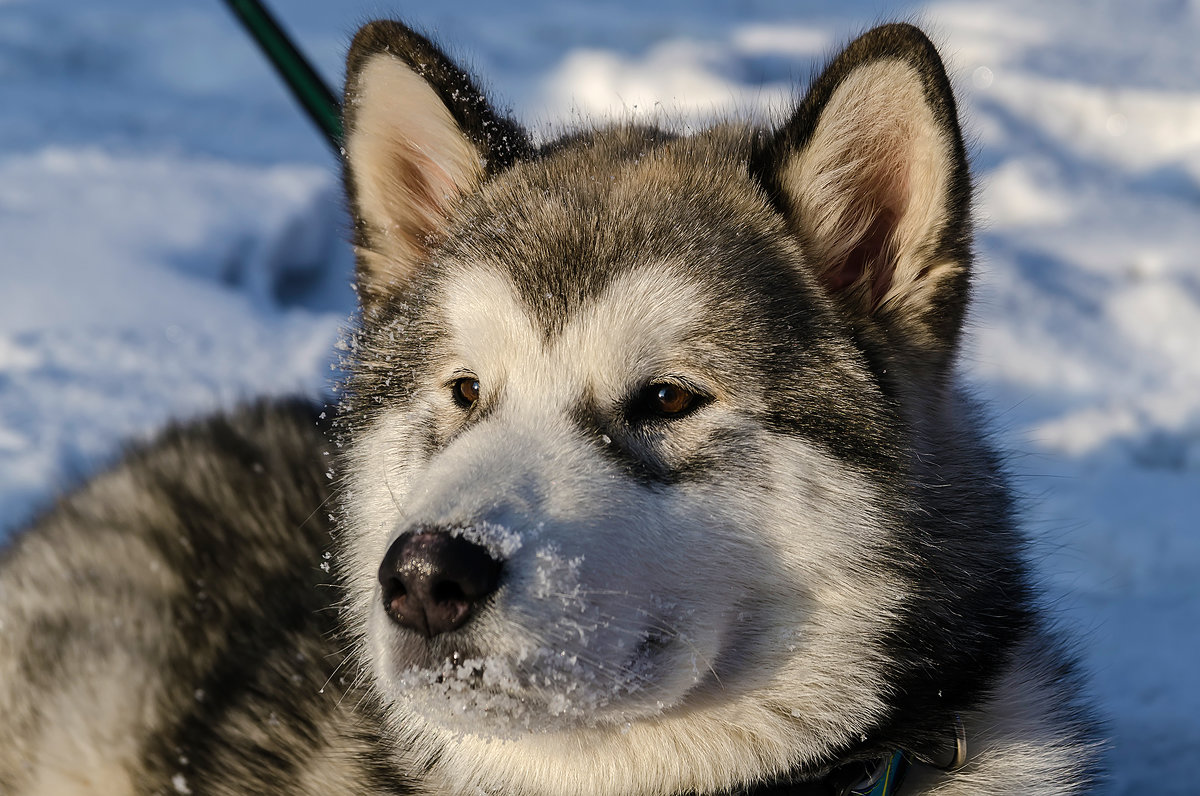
xmin=0 ymin=401 xmax=412 ymax=796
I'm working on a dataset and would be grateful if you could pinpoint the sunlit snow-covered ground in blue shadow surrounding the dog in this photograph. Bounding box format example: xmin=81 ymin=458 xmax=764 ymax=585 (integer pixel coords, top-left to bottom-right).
xmin=0 ymin=0 xmax=1200 ymax=794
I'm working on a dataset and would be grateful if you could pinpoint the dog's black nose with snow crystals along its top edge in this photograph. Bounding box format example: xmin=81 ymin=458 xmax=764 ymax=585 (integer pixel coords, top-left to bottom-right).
xmin=379 ymin=529 xmax=500 ymax=639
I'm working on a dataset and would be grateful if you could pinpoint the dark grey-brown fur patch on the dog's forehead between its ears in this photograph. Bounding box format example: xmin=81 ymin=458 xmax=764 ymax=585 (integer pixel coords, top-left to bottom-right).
xmin=439 ymin=127 xmax=794 ymax=336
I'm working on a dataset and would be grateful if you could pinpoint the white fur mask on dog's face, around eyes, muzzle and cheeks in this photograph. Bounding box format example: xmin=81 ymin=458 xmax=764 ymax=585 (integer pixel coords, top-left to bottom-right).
xmin=349 ymin=264 xmax=906 ymax=796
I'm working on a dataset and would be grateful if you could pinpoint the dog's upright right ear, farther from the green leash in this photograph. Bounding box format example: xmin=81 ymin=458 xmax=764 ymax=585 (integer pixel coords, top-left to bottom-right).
xmin=755 ymin=24 xmax=971 ymax=365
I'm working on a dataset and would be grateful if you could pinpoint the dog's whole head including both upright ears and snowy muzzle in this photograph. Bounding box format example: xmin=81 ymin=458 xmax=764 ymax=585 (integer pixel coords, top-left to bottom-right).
xmin=343 ymin=23 xmax=966 ymax=792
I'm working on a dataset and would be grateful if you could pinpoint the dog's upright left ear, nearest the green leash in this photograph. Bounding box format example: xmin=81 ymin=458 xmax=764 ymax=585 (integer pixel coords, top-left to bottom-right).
xmin=342 ymin=20 xmax=529 ymax=310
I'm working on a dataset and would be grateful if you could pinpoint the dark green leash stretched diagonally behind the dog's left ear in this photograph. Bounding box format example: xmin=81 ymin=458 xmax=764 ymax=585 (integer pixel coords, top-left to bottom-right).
xmin=218 ymin=0 xmax=343 ymax=157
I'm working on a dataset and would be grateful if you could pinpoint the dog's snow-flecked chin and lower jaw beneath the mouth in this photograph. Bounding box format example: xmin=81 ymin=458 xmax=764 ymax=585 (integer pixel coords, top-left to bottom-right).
xmin=377 ymin=632 xmax=710 ymax=738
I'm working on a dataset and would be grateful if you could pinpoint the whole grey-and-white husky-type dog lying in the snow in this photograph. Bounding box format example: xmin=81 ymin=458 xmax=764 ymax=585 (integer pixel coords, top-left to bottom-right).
xmin=0 ymin=22 xmax=1099 ymax=796
